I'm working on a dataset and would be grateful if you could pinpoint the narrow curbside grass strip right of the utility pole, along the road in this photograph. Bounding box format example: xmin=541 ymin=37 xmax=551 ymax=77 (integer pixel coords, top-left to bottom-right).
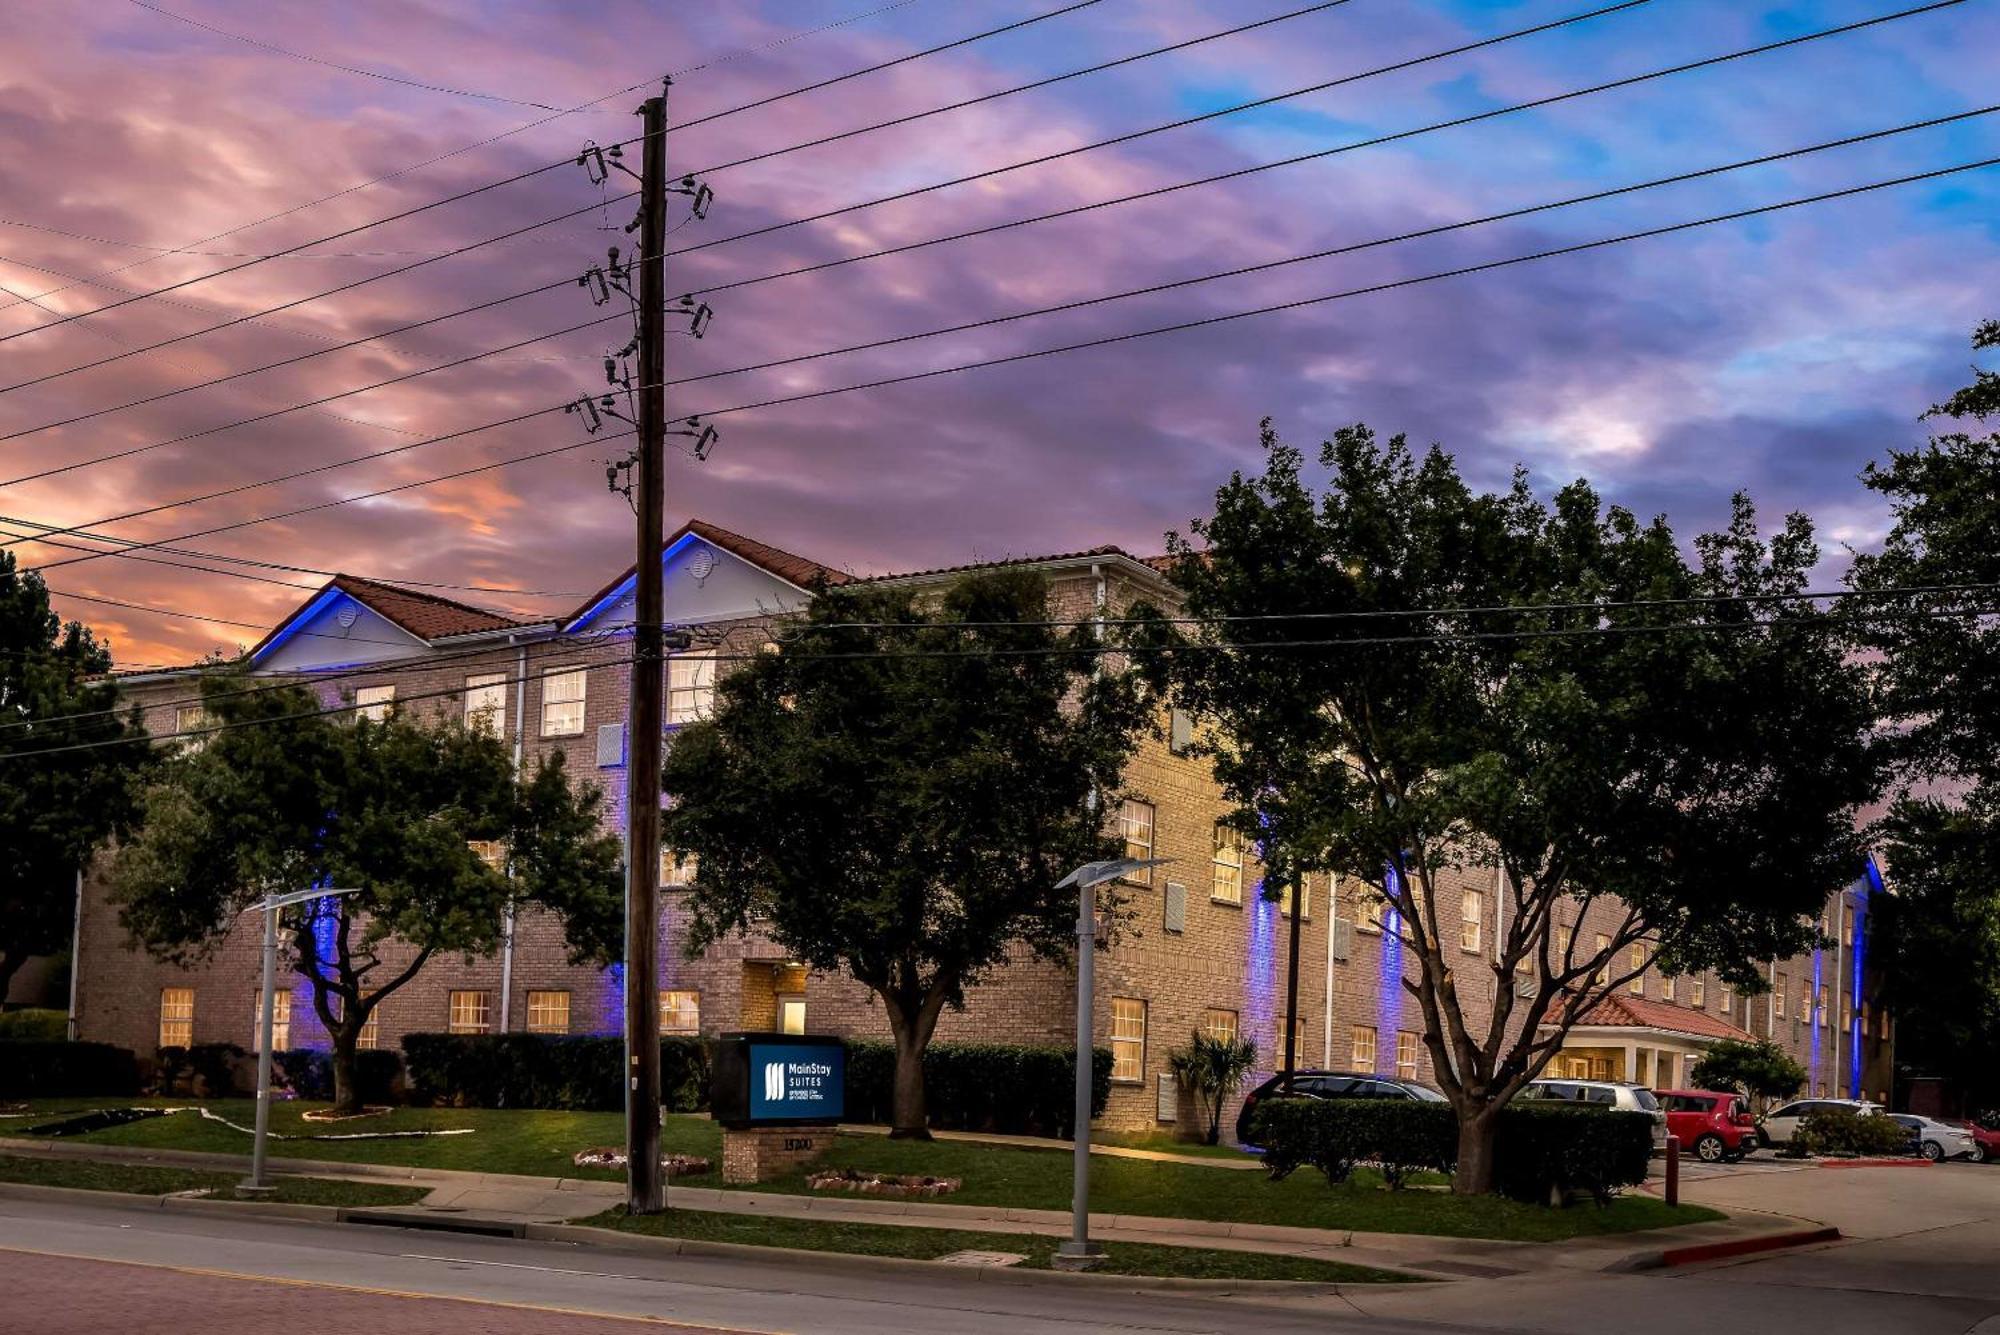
xmin=578 ymin=1209 xmax=1414 ymax=1283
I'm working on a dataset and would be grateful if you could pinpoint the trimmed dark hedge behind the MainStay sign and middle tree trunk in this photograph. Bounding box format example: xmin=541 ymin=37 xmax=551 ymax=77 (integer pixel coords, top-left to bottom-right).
xmin=846 ymin=1039 xmax=1112 ymax=1137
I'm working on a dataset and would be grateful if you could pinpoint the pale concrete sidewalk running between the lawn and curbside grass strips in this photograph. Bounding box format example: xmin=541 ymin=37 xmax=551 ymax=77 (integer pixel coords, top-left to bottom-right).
xmin=0 ymin=1139 xmax=1808 ymax=1279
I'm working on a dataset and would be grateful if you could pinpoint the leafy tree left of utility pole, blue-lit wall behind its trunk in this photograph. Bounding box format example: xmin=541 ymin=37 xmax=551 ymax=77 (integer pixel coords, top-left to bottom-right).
xmin=112 ymin=671 xmax=624 ymax=1111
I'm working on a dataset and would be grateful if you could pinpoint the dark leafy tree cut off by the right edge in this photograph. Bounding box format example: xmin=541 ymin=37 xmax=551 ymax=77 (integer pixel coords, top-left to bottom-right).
xmin=1848 ymin=320 xmax=2000 ymax=1105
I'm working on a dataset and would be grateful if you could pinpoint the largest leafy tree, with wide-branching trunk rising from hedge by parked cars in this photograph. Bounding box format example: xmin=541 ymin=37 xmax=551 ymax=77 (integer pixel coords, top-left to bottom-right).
xmin=1144 ymin=424 xmax=1876 ymax=1193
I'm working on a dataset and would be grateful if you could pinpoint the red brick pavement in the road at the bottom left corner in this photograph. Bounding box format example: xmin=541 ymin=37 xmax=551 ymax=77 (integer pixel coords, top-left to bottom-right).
xmin=0 ymin=1251 xmax=718 ymax=1335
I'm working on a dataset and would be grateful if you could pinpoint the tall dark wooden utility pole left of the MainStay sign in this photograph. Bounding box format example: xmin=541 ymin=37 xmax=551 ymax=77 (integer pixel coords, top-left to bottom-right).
xmin=624 ymin=94 xmax=666 ymax=1215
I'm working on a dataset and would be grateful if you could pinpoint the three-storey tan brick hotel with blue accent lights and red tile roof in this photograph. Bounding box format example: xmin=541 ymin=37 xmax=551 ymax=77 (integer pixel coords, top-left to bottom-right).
xmin=76 ymin=522 xmax=1892 ymax=1129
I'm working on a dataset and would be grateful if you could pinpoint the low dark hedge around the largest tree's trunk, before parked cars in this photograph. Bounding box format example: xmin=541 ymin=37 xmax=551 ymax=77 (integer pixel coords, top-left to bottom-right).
xmin=1250 ymin=1099 xmax=1652 ymax=1203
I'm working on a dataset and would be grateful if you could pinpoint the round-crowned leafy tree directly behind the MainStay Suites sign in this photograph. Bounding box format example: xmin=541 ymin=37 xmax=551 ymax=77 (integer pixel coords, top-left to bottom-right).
xmin=662 ymin=572 xmax=1144 ymax=1137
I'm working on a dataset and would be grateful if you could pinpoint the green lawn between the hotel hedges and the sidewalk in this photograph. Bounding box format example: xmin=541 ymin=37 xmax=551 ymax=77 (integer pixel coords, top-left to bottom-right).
xmin=0 ymin=1099 xmax=1720 ymax=1241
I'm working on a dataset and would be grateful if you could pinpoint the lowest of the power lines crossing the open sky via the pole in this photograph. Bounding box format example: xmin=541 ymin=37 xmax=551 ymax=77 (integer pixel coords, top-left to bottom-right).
xmin=28 ymin=158 xmax=2000 ymax=583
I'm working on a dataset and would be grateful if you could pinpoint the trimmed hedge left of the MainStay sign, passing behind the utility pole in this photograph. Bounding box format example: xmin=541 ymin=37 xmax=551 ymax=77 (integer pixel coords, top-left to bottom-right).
xmin=402 ymin=1033 xmax=708 ymax=1113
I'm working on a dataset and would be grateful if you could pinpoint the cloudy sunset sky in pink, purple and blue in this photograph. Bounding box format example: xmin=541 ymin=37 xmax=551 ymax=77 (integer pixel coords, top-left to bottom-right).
xmin=0 ymin=0 xmax=2000 ymax=666
